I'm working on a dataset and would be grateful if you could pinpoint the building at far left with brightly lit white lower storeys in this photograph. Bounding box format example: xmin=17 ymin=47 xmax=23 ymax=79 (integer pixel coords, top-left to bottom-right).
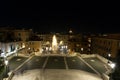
xmin=0 ymin=28 xmax=32 ymax=57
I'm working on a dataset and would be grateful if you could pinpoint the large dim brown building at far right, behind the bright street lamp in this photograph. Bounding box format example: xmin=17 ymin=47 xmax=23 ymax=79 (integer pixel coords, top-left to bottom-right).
xmin=91 ymin=34 xmax=120 ymax=58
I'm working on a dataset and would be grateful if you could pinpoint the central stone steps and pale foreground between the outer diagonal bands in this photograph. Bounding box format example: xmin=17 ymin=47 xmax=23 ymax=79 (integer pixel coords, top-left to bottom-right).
xmin=12 ymin=55 xmax=102 ymax=80
